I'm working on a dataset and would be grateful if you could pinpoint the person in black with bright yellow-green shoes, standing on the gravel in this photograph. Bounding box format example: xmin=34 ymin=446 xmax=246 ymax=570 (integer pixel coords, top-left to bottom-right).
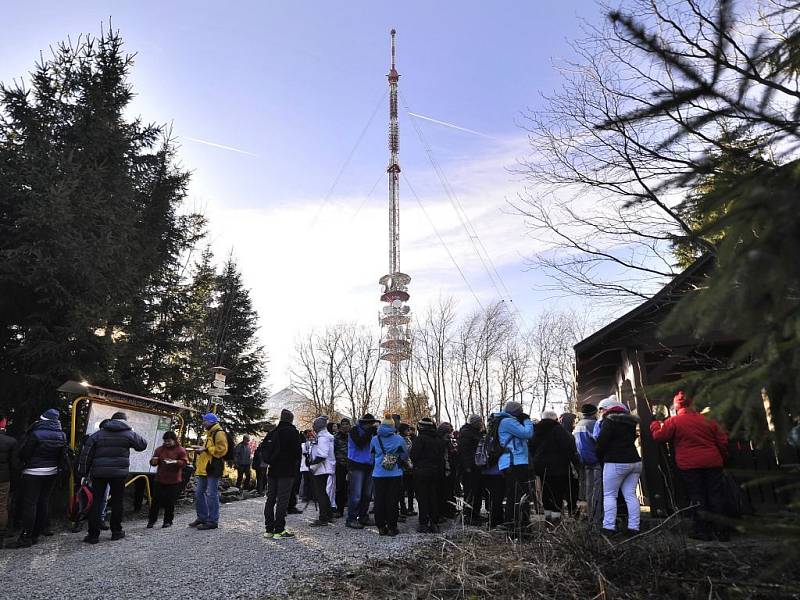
xmin=260 ymin=408 xmax=302 ymax=540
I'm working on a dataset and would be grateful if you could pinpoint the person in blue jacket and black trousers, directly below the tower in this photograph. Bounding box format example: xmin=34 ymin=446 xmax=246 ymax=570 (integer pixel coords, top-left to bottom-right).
xmin=370 ymin=419 xmax=408 ymax=536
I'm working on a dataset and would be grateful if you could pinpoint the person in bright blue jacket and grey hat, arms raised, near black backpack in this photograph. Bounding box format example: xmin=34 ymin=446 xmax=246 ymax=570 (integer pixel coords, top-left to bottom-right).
xmin=496 ymin=400 xmax=533 ymax=531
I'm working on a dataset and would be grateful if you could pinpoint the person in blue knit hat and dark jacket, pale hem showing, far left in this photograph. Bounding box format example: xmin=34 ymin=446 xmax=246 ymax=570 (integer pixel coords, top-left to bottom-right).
xmin=6 ymin=408 xmax=67 ymax=548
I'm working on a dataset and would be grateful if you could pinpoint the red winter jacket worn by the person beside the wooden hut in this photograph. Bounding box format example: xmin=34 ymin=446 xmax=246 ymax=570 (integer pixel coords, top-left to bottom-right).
xmin=650 ymin=408 xmax=728 ymax=470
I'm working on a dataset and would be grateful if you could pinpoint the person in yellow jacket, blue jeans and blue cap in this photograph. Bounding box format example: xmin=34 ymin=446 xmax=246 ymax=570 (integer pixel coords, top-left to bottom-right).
xmin=189 ymin=413 xmax=228 ymax=530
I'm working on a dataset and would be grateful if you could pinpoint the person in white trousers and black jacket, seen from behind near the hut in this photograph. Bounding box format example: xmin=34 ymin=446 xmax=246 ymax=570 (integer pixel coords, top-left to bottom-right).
xmin=596 ymin=404 xmax=642 ymax=534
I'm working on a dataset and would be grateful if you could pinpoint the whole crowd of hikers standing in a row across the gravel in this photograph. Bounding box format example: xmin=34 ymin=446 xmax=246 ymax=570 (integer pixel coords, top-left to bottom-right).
xmin=0 ymin=392 xmax=728 ymax=548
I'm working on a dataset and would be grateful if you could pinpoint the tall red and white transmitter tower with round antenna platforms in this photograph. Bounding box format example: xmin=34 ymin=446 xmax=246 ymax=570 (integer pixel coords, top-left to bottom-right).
xmin=379 ymin=29 xmax=411 ymax=411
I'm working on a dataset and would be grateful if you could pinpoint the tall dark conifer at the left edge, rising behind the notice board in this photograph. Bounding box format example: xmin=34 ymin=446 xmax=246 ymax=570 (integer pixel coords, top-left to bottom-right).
xmin=0 ymin=31 xmax=193 ymax=424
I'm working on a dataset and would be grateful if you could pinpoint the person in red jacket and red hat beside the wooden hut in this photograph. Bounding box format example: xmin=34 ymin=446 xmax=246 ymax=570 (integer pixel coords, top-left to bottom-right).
xmin=650 ymin=391 xmax=730 ymax=541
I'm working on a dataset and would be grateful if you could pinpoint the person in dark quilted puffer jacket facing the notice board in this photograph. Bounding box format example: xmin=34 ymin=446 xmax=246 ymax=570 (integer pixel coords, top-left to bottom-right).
xmin=78 ymin=412 xmax=147 ymax=544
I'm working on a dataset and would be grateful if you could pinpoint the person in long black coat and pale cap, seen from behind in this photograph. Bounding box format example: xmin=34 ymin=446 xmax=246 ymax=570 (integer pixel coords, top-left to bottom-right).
xmin=528 ymin=410 xmax=580 ymax=521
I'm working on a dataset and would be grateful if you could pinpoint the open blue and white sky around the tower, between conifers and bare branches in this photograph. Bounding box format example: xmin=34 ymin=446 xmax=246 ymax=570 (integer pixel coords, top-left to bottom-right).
xmin=0 ymin=0 xmax=601 ymax=391
